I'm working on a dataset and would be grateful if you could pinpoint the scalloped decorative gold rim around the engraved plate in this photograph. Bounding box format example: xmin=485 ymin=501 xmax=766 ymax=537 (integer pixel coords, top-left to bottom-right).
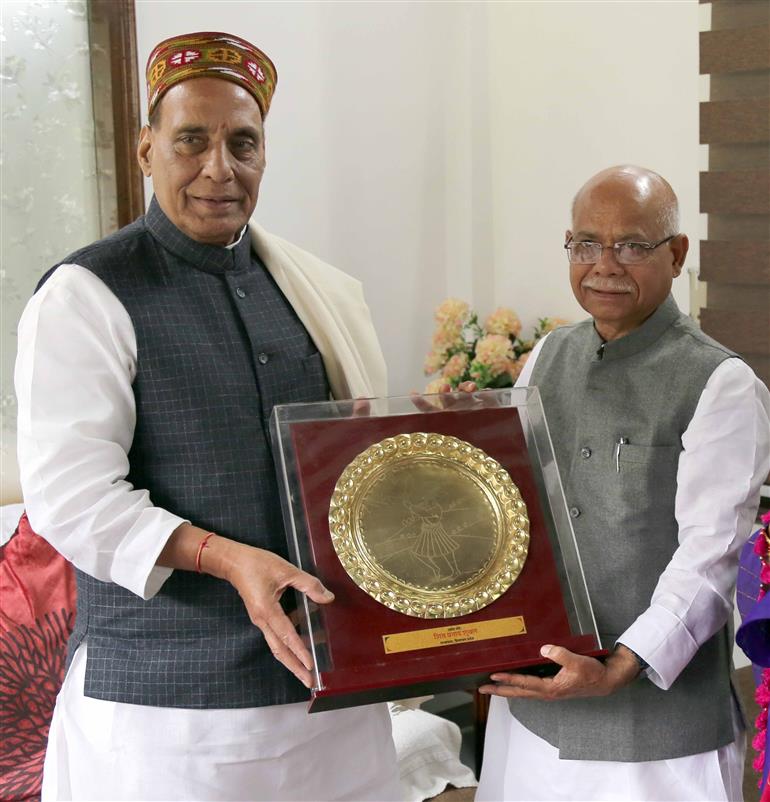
xmin=329 ymin=432 xmax=529 ymax=618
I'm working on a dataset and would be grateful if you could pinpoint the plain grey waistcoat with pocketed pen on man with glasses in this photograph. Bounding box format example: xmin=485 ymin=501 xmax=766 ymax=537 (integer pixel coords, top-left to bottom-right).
xmin=510 ymin=296 xmax=734 ymax=761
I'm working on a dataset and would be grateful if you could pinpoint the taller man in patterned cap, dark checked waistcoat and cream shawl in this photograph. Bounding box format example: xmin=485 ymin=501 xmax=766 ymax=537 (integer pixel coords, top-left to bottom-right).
xmin=16 ymin=33 xmax=399 ymax=800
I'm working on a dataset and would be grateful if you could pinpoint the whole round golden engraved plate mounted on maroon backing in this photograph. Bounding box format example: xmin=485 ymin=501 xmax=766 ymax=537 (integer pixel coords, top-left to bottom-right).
xmin=329 ymin=432 xmax=529 ymax=618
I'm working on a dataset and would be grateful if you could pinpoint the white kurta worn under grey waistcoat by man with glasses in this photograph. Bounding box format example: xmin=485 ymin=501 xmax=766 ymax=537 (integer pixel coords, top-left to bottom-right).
xmin=476 ymin=334 xmax=770 ymax=801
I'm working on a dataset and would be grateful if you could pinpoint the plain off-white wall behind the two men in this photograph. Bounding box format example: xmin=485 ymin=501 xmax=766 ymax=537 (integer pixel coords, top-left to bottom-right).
xmin=136 ymin=0 xmax=699 ymax=393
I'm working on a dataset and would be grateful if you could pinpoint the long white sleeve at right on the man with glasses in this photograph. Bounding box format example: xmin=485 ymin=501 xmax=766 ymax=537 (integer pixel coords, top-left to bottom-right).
xmin=618 ymin=359 xmax=770 ymax=689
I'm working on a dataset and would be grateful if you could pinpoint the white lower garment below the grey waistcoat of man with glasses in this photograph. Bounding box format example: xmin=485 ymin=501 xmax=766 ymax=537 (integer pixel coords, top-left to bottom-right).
xmin=476 ymin=696 xmax=746 ymax=802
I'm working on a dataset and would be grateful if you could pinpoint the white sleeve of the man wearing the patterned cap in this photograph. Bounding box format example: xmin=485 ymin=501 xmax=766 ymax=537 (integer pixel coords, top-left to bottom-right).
xmin=15 ymin=265 xmax=185 ymax=599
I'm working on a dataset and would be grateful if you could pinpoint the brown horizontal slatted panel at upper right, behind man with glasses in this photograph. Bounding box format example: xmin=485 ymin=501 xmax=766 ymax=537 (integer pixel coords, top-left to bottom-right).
xmin=700 ymin=0 xmax=770 ymax=400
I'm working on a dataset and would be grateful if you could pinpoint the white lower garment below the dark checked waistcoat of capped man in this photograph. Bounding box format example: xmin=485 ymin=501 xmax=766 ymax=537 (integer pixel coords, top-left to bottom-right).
xmin=42 ymin=645 xmax=401 ymax=802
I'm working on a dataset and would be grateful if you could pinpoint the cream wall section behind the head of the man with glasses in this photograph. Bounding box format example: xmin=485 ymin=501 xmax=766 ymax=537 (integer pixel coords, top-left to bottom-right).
xmin=489 ymin=2 xmax=700 ymax=319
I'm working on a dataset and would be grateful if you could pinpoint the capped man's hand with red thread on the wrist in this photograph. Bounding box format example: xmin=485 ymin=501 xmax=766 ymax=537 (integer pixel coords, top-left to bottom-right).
xmin=157 ymin=524 xmax=334 ymax=688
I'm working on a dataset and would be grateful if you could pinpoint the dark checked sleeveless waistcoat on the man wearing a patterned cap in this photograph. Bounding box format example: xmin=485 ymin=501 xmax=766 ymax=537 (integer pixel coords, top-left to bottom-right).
xmin=43 ymin=200 xmax=329 ymax=708
